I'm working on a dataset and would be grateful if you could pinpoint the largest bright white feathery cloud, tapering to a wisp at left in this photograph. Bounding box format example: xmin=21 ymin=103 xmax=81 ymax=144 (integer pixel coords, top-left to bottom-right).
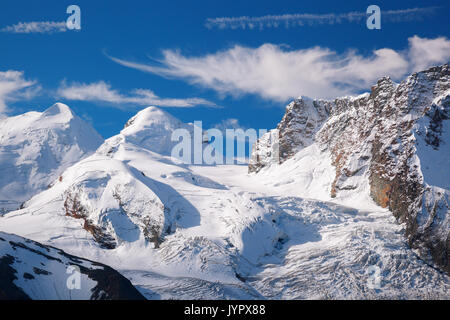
xmin=110 ymin=36 xmax=450 ymax=101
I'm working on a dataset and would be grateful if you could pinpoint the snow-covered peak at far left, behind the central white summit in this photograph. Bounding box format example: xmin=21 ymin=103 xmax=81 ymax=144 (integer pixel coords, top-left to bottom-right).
xmin=0 ymin=103 xmax=103 ymax=213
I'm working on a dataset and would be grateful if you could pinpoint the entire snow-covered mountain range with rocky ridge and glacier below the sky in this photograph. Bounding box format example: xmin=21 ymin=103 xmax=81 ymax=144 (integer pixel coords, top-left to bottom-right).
xmin=0 ymin=65 xmax=450 ymax=299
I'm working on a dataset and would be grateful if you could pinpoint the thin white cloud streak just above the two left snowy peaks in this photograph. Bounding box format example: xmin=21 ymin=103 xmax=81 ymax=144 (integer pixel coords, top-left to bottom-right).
xmin=57 ymin=81 xmax=217 ymax=108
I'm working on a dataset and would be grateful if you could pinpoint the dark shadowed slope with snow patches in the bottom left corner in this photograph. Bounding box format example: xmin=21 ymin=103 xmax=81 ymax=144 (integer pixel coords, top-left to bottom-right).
xmin=0 ymin=232 xmax=144 ymax=300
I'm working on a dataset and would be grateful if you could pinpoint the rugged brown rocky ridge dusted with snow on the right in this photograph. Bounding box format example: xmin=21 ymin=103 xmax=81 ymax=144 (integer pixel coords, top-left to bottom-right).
xmin=249 ymin=64 xmax=450 ymax=273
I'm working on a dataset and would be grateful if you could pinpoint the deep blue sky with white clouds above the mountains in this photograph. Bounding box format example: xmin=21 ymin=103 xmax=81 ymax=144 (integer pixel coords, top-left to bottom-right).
xmin=0 ymin=0 xmax=450 ymax=138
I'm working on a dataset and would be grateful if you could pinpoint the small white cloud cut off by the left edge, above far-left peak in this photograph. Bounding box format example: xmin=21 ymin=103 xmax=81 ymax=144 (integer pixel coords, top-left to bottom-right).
xmin=0 ymin=70 xmax=41 ymax=116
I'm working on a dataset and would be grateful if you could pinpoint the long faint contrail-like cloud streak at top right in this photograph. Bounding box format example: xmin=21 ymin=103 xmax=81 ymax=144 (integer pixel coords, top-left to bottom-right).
xmin=205 ymin=7 xmax=437 ymax=30
